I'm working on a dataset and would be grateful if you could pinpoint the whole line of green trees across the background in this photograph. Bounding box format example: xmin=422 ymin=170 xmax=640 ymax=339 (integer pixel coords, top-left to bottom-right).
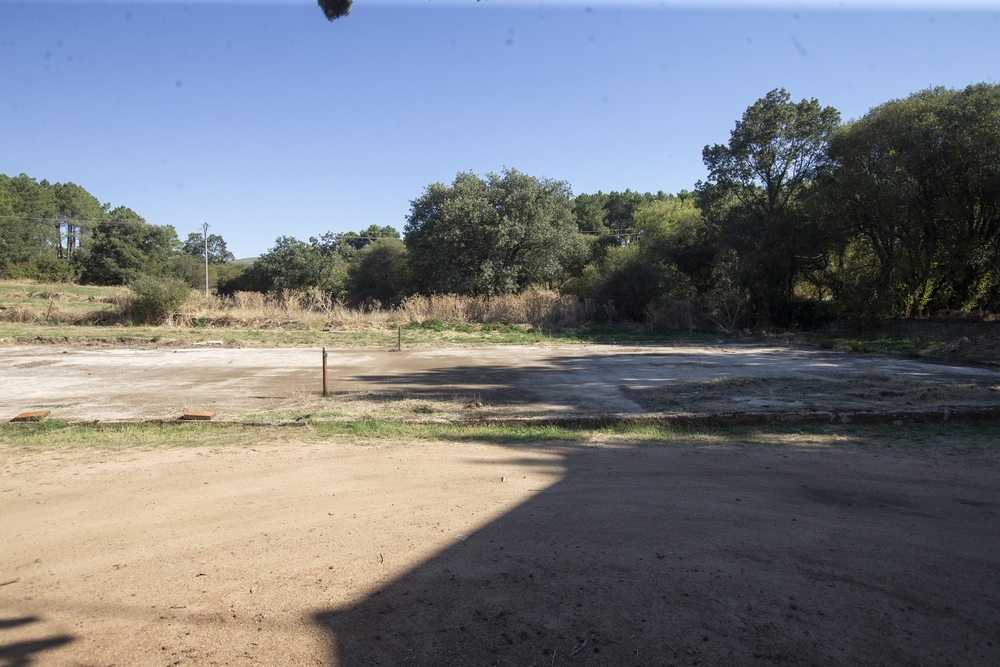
xmin=0 ymin=83 xmax=1000 ymax=329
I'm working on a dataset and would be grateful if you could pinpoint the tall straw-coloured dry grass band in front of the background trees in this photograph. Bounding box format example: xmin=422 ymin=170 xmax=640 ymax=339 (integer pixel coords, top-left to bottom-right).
xmin=0 ymin=284 xmax=596 ymax=331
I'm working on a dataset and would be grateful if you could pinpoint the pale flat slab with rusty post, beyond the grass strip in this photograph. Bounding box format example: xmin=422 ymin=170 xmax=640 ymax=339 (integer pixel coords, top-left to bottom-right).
xmin=0 ymin=345 xmax=1000 ymax=420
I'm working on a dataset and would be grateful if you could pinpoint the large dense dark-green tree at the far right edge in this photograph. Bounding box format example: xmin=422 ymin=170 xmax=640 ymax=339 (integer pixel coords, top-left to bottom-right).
xmin=827 ymin=84 xmax=1000 ymax=319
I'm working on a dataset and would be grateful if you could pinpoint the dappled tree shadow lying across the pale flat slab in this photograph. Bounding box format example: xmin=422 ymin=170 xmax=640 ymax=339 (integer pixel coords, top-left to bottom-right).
xmin=335 ymin=348 xmax=1000 ymax=414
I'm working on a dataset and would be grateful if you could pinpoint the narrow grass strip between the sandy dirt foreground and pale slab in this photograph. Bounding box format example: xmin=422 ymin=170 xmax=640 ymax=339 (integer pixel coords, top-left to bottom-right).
xmin=0 ymin=420 xmax=1000 ymax=460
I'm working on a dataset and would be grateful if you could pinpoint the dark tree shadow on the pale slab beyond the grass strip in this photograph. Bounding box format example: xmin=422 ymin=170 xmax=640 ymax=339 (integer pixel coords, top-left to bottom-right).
xmin=335 ymin=348 xmax=1000 ymax=414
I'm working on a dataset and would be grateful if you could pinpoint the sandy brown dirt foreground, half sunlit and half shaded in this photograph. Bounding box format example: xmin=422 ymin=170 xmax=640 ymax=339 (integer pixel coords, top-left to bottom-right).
xmin=0 ymin=431 xmax=1000 ymax=667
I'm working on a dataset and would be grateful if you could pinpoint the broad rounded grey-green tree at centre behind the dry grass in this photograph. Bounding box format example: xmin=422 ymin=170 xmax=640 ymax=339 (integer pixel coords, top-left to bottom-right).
xmin=405 ymin=169 xmax=578 ymax=296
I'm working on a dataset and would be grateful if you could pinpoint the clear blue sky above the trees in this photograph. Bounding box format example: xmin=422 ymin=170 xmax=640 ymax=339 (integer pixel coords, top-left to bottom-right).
xmin=0 ymin=0 xmax=1000 ymax=257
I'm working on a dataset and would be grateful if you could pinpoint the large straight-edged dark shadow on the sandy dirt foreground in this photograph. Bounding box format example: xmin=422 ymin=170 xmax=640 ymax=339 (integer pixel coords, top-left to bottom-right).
xmin=314 ymin=447 xmax=1000 ymax=667
